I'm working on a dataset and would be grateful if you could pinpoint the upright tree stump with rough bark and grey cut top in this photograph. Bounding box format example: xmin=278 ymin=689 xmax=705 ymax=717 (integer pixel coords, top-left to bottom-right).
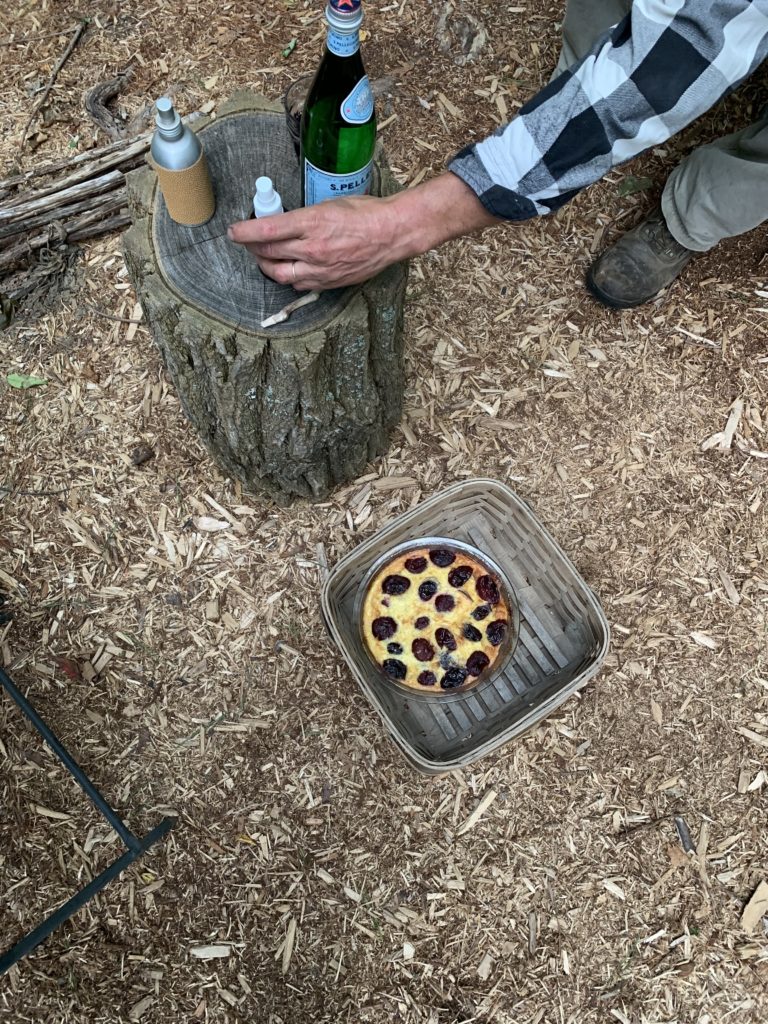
xmin=124 ymin=93 xmax=407 ymax=501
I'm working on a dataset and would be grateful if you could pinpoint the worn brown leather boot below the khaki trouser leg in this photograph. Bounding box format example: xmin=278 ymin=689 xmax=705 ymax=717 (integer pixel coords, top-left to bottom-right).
xmin=587 ymin=206 xmax=694 ymax=309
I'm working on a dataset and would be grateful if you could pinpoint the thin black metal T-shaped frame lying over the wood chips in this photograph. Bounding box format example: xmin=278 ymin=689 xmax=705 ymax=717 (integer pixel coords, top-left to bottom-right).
xmin=0 ymin=669 xmax=176 ymax=974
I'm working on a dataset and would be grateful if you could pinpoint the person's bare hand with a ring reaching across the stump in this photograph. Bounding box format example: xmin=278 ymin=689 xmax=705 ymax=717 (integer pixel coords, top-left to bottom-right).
xmin=227 ymin=173 xmax=498 ymax=292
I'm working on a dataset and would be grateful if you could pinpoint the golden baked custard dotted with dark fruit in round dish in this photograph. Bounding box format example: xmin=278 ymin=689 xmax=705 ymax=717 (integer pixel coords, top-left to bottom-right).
xmin=362 ymin=546 xmax=511 ymax=692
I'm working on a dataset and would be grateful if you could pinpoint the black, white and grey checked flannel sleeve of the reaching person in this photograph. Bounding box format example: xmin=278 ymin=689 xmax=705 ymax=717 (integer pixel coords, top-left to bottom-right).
xmin=449 ymin=0 xmax=768 ymax=220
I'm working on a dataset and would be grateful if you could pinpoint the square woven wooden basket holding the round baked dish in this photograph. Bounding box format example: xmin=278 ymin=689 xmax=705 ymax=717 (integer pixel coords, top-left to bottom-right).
xmin=322 ymin=479 xmax=610 ymax=775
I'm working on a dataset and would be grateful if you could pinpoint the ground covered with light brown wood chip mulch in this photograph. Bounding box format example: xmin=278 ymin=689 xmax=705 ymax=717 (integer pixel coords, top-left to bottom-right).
xmin=0 ymin=0 xmax=768 ymax=1024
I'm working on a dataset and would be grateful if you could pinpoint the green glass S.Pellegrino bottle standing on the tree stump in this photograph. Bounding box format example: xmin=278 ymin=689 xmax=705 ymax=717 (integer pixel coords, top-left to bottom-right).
xmin=301 ymin=0 xmax=376 ymax=206
